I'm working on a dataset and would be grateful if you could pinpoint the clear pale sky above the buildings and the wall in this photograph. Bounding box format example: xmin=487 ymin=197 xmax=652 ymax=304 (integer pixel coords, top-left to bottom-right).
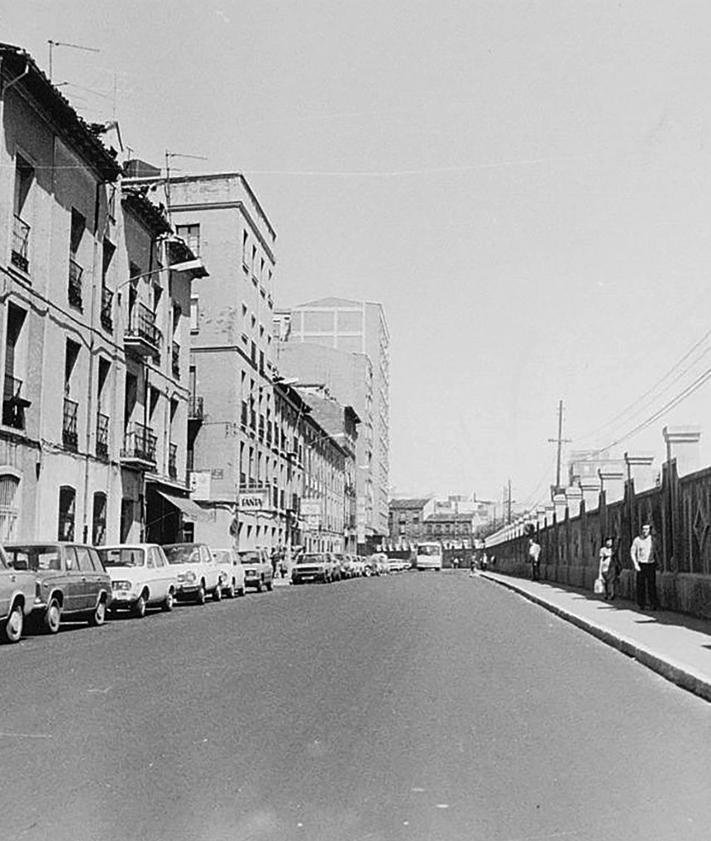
xmin=0 ymin=0 xmax=711 ymax=502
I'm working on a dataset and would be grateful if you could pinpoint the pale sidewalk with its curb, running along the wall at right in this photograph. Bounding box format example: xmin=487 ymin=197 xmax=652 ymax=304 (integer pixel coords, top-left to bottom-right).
xmin=479 ymin=570 xmax=711 ymax=701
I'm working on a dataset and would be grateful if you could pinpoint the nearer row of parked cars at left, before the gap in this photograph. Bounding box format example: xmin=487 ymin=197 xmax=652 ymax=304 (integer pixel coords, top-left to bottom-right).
xmin=0 ymin=542 xmax=273 ymax=642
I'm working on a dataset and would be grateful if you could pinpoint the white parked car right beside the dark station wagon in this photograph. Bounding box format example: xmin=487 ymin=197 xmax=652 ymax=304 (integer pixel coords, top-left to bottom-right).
xmin=96 ymin=543 xmax=178 ymax=618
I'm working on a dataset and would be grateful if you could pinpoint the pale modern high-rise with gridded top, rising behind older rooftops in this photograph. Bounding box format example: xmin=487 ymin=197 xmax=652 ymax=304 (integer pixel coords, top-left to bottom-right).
xmin=273 ymin=298 xmax=390 ymax=551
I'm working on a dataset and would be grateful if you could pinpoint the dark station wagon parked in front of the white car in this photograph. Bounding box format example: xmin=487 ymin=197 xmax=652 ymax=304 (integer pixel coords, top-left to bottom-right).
xmin=5 ymin=542 xmax=112 ymax=634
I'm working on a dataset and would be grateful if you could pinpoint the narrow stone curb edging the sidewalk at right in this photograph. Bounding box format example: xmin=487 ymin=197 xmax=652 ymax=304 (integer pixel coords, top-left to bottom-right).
xmin=480 ymin=573 xmax=711 ymax=701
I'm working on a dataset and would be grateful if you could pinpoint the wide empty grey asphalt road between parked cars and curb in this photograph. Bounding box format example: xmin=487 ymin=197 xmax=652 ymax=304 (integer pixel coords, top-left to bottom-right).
xmin=0 ymin=572 xmax=711 ymax=841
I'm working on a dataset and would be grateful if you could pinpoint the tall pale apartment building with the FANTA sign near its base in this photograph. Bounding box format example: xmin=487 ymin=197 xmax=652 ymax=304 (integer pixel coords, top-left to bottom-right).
xmin=133 ymin=173 xmax=286 ymax=549
